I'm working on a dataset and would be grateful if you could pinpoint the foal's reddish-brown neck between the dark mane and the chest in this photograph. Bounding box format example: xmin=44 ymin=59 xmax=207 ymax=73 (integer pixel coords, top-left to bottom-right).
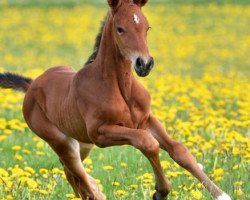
xmin=95 ymin=13 xmax=133 ymax=101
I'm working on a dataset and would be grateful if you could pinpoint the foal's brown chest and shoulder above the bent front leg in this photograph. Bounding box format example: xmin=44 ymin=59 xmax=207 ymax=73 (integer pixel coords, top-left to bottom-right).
xmin=78 ymin=72 xmax=150 ymax=132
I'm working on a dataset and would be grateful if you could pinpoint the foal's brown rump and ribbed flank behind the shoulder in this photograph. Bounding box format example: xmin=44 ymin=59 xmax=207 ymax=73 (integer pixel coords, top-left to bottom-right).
xmin=23 ymin=68 xmax=90 ymax=143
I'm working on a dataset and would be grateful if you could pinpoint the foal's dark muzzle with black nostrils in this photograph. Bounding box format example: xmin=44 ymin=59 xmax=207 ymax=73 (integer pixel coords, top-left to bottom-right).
xmin=134 ymin=57 xmax=154 ymax=77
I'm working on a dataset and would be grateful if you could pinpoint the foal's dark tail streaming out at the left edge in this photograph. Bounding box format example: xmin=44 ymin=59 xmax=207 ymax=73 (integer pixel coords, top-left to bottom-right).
xmin=0 ymin=72 xmax=32 ymax=92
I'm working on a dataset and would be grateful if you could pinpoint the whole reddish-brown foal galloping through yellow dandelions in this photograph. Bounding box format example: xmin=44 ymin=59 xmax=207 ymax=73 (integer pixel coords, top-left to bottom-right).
xmin=0 ymin=0 xmax=230 ymax=200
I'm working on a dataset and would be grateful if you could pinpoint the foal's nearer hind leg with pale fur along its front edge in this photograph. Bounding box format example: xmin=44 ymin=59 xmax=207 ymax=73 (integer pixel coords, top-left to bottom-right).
xmin=25 ymin=104 xmax=104 ymax=200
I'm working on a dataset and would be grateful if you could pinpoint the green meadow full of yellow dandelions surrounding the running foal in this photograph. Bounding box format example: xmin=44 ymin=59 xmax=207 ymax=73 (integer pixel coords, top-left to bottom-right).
xmin=0 ymin=1 xmax=250 ymax=200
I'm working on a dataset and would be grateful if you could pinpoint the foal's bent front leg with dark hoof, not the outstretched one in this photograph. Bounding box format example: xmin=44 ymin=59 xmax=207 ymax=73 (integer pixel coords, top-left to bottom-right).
xmin=93 ymin=125 xmax=170 ymax=200
